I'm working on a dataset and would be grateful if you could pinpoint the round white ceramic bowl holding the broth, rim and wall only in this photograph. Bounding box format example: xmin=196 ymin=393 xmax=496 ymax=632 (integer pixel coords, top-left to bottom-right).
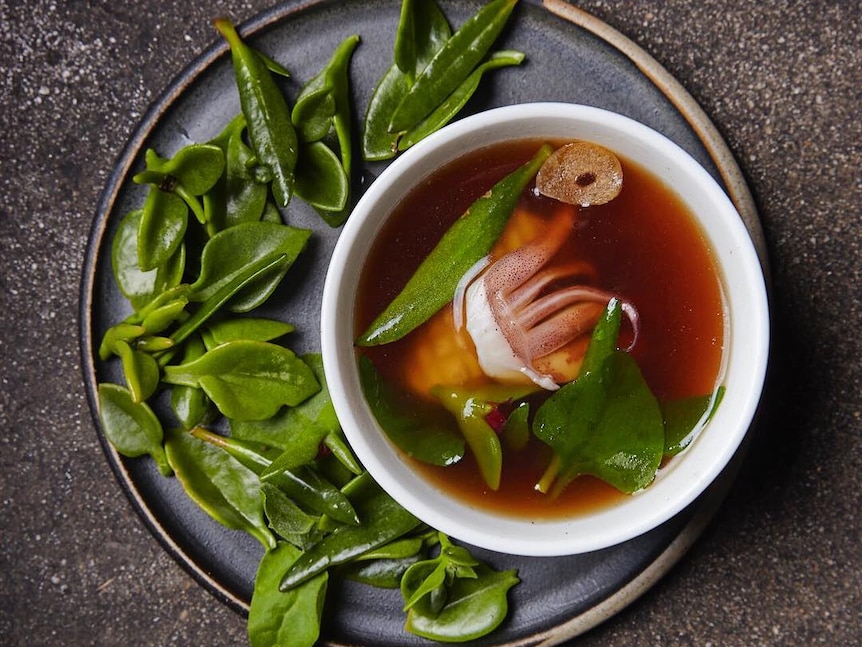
xmin=321 ymin=103 xmax=769 ymax=556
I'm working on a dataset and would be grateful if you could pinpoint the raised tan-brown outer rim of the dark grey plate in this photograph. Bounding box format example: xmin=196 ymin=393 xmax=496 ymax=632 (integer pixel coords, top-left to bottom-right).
xmin=78 ymin=0 xmax=771 ymax=647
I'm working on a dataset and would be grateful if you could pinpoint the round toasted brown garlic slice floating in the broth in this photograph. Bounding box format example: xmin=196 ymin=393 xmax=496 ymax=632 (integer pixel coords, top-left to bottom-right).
xmin=536 ymin=142 xmax=623 ymax=207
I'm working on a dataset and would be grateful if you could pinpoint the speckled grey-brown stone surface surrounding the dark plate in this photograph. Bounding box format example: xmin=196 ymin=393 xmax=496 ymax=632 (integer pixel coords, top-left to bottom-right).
xmin=0 ymin=0 xmax=862 ymax=647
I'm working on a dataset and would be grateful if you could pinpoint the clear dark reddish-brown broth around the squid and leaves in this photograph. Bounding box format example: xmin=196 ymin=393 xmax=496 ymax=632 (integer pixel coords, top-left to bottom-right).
xmin=356 ymin=141 xmax=723 ymax=518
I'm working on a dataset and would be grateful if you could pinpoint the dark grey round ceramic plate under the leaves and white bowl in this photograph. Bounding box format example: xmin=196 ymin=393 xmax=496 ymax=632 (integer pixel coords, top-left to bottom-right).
xmin=81 ymin=0 xmax=762 ymax=646
